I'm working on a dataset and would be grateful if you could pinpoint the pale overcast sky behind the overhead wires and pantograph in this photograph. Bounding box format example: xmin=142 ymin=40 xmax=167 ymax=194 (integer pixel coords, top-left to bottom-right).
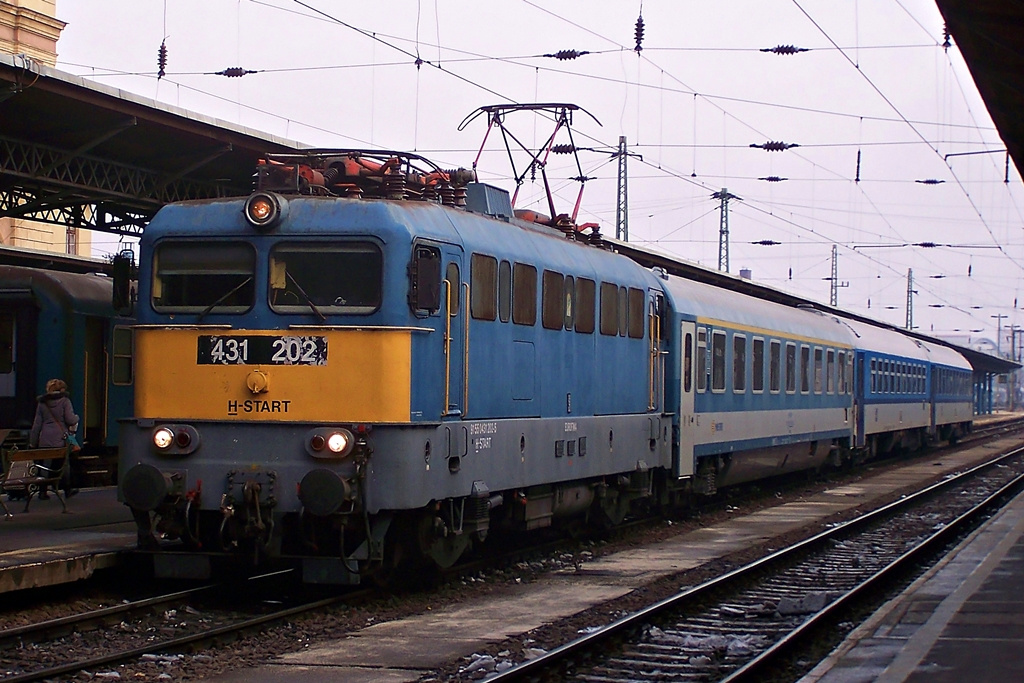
xmin=56 ymin=0 xmax=1024 ymax=350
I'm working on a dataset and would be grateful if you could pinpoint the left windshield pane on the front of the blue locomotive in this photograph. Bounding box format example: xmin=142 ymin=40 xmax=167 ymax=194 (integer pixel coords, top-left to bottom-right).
xmin=153 ymin=240 xmax=256 ymax=313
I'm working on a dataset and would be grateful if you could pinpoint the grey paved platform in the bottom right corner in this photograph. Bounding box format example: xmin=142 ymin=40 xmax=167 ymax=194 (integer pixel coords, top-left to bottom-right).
xmin=801 ymin=485 xmax=1024 ymax=683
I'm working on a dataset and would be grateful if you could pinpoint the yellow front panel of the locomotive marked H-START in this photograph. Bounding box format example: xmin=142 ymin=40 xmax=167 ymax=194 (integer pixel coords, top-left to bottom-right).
xmin=135 ymin=328 xmax=412 ymax=422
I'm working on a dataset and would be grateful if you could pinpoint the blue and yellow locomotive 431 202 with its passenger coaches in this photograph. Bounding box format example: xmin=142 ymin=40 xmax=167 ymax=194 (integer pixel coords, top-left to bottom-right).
xmin=119 ymin=151 xmax=973 ymax=584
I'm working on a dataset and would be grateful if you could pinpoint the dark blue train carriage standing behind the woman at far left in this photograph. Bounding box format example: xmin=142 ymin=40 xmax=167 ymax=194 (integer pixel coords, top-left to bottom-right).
xmin=0 ymin=265 xmax=132 ymax=485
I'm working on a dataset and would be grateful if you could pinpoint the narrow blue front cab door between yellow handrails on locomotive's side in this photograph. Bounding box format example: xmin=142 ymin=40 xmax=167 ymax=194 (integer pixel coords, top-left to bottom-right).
xmin=441 ymin=252 xmax=469 ymax=417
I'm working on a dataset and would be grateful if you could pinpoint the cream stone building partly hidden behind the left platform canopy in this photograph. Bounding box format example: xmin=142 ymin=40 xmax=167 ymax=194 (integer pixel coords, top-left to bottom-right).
xmin=0 ymin=0 xmax=92 ymax=256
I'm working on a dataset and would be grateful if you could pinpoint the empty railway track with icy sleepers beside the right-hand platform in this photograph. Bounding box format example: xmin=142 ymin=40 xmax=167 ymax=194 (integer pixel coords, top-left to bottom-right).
xmin=487 ymin=440 xmax=1024 ymax=683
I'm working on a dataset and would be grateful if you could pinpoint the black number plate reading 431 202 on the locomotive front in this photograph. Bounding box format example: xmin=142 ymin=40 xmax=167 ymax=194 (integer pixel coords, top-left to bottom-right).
xmin=196 ymin=335 xmax=327 ymax=366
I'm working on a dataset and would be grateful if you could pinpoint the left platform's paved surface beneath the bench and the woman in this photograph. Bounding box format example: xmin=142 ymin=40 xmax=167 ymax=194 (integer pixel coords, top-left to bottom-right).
xmin=0 ymin=486 xmax=136 ymax=593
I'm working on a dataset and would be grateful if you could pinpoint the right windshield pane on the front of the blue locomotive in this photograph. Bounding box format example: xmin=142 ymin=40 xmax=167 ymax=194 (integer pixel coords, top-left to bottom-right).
xmin=269 ymin=242 xmax=383 ymax=313
